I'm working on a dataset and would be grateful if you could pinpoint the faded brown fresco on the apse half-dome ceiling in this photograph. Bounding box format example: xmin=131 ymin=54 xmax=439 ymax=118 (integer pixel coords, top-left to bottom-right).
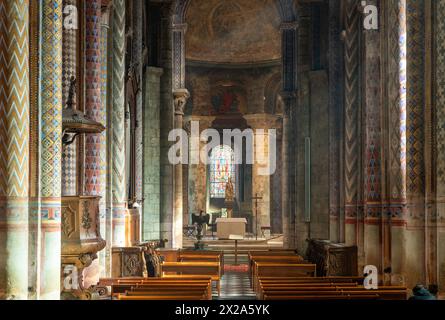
xmin=186 ymin=0 xmax=281 ymax=64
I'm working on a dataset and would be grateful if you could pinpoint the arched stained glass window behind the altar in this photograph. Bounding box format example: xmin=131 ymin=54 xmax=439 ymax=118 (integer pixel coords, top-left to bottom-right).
xmin=210 ymin=145 xmax=235 ymax=198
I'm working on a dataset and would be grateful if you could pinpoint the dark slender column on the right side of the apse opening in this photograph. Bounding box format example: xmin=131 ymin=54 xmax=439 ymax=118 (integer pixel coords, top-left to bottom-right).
xmin=281 ymin=21 xmax=298 ymax=248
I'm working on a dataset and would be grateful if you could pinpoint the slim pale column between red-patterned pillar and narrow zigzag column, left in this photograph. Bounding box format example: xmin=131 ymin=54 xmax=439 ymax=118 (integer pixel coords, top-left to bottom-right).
xmin=99 ymin=3 xmax=111 ymax=278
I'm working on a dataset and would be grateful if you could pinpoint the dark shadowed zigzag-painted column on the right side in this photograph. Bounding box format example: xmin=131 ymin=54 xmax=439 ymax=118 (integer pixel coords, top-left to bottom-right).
xmin=344 ymin=0 xmax=360 ymax=244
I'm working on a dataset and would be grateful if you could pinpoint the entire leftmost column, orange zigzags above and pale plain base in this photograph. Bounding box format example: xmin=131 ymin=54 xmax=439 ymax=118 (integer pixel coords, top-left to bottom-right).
xmin=0 ymin=0 xmax=29 ymax=300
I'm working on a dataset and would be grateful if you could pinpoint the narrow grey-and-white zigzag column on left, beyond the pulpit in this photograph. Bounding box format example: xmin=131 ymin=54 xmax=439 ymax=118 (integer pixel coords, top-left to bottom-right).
xmin=110 ymin=0 xmax=127 ymax=247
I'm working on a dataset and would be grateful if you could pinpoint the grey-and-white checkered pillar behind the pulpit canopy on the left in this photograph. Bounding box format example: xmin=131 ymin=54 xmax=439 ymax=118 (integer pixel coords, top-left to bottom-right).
xmin=62 ymin=0 xmax=80 ymax=196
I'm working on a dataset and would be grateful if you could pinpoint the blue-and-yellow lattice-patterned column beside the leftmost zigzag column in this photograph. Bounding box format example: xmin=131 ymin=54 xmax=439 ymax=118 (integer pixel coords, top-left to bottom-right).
xmin=38 ymin=0 xmax=63 ymax=300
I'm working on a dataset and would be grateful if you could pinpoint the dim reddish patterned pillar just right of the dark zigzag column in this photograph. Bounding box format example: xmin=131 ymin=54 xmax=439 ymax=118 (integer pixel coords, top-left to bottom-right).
xmin=359 ymin=1 xmax=383 ymax=274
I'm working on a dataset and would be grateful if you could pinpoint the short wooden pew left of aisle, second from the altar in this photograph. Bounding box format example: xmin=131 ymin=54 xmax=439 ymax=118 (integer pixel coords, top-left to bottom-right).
xmin=161 ymin=261 xmax=221 ymax=295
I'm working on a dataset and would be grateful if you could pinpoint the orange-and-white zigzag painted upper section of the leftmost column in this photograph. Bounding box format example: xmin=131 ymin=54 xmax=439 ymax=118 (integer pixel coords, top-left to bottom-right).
xmin=0 ymin=0 xmax=29 ymax=197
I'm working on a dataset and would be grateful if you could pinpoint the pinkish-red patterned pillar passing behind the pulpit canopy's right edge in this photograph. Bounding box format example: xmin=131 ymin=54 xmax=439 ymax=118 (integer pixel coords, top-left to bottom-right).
xmin=84 ymin=0 xmax=106 ymax=283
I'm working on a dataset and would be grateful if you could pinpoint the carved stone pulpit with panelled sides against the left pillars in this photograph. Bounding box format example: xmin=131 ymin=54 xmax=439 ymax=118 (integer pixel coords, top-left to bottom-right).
xmin=61 ymin=196 xmax=106 ymax=299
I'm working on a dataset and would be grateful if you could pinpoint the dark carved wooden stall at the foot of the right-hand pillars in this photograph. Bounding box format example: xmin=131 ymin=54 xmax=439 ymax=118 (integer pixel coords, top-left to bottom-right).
xmin=306 ymin=239 xmax=358 ymax=277
